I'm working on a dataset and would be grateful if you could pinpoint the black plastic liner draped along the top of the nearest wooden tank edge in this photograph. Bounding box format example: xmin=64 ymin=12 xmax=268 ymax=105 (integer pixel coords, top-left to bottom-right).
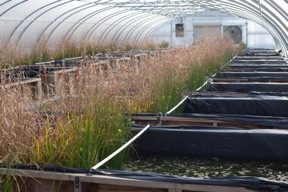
xmin=0 ymin=164 xmax=288 ymax=192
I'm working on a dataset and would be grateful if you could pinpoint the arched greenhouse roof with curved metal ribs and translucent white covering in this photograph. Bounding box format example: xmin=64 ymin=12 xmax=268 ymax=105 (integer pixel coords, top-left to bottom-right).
xmin=0 ymin=0 xmax=288 ymax=57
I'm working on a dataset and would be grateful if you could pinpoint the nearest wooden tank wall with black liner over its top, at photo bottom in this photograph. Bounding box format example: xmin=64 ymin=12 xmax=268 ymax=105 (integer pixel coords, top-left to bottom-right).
xmin=0 ymin=165 xmax=288 ymax=192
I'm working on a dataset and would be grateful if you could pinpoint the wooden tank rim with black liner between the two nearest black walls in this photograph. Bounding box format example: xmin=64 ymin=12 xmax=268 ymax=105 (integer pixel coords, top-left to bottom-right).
xmin=131 ymin=113 xmax=288 ymax=130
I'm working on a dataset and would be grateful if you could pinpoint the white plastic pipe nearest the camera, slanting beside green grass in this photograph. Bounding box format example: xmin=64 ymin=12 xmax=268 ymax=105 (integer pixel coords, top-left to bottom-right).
xmin=90 ymin=124 xmax=150 ymax=171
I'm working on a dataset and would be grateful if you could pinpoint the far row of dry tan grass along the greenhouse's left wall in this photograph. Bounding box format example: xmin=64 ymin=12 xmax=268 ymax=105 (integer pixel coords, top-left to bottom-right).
xmin=0 ymin=37 xmax=163 ymax=69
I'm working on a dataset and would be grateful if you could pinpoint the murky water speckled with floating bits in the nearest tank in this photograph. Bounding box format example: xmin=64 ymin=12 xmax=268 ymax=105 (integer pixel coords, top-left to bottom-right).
xmin=123 ymin=157 xmax=288 ymax=182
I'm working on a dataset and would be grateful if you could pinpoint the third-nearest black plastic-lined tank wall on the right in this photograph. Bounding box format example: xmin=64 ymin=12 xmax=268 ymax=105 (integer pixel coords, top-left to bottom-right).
xmin=207 ymin=82 xmax=288 ymax=92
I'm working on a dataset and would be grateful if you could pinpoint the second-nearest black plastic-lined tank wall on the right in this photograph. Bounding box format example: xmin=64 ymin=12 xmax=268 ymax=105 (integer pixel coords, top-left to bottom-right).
xmin=183 ymin=95 xmax=288 ymax=117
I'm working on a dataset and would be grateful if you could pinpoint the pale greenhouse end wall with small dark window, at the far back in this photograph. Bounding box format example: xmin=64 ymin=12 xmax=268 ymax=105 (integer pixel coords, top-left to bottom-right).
xmin=151 ymin=11 xmax=276 ymax=49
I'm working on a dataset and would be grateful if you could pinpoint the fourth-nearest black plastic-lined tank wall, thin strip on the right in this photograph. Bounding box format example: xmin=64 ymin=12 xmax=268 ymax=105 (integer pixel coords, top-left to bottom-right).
xmin=215 ymin=72 xmax=288 ymax=78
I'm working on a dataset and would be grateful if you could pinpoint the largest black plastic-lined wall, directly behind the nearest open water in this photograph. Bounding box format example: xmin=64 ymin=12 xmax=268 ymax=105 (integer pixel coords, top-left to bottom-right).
xmin=135 ymin=126 xmax=288 ymax=161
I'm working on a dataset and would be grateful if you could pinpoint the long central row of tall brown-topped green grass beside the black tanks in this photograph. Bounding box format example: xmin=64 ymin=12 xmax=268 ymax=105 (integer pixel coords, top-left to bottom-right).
xmin=0 ymin=40 xmax=238 ymax=168
